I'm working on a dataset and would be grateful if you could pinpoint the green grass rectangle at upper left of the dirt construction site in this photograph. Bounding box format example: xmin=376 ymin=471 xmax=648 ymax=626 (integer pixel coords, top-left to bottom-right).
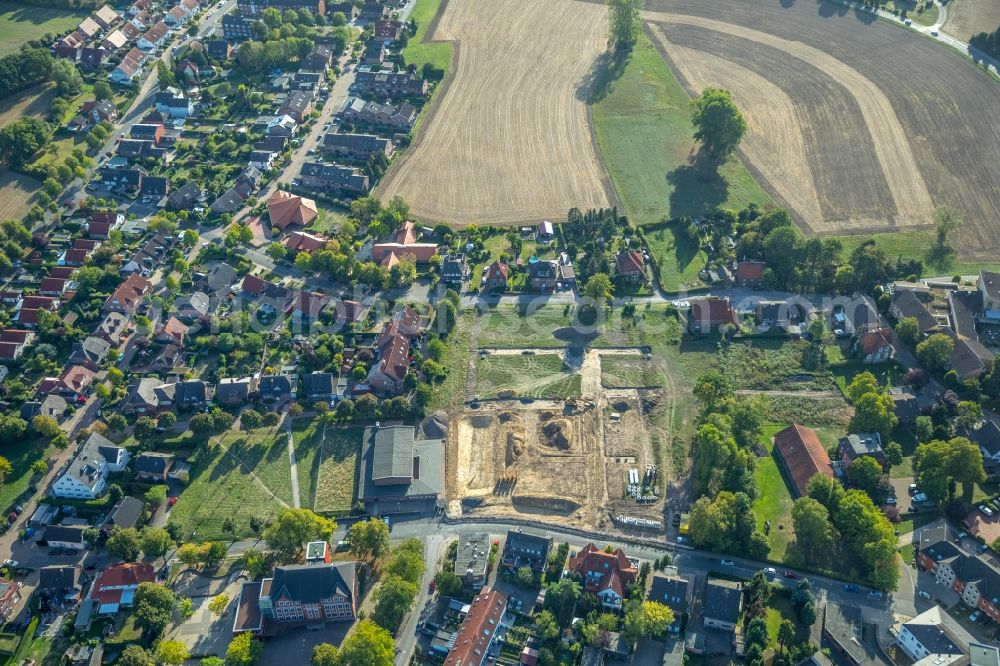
xmin=476 ymin=354 xmax=581 ymax=398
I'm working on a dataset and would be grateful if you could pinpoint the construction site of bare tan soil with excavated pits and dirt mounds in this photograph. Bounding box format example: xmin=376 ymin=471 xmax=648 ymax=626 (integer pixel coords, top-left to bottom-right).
xmin=447 ymin=349 xmax=683 ymax=534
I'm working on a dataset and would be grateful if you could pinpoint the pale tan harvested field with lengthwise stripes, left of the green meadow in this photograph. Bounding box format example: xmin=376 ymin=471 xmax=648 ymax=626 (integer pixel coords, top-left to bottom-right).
xmin=378 ymin=0 xmax=613 ymax=225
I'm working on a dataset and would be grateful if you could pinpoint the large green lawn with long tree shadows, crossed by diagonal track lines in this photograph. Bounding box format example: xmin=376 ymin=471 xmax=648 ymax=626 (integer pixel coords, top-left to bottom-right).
xmin=170 ymin=427 xmax=292 ymax=541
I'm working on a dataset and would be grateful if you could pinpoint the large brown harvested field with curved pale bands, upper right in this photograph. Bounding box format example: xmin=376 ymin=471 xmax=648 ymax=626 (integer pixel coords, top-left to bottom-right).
xmin=600 ymin=0 xmax=1000 ymax=254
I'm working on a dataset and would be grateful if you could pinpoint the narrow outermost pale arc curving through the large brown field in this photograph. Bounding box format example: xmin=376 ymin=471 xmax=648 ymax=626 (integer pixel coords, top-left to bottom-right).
xmin=643 ymin=12 xmax=934 ymax=231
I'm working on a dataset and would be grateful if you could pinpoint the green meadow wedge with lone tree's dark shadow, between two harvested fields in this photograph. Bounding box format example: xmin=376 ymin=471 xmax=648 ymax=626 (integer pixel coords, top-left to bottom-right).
xmin=592 ymin=34 xmax=770 ymax=290
